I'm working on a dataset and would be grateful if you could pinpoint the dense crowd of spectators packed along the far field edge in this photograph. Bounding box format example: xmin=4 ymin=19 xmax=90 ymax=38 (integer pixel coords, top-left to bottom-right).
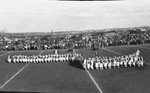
xmin=0 ymin=28 xmax=150 ymax=51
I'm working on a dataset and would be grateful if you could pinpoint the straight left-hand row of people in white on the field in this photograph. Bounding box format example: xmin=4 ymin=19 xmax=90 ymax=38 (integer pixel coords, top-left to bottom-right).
xmin=7 ymin=51 xmax=76 ymax=63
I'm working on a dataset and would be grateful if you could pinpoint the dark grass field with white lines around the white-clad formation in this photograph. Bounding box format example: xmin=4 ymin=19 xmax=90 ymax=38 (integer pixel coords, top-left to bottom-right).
xmin=0 ymin=45 xmax=150 ymax=93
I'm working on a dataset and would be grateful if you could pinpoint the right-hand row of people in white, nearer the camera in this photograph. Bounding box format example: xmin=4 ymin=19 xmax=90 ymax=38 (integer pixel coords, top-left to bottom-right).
xmin=82 ymin=50 xmax=143 ymax=69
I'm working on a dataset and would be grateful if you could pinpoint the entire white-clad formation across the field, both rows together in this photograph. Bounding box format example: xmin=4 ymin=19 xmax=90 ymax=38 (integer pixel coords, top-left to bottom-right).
xmin=7 ymin=50 xmax=144 ymax=70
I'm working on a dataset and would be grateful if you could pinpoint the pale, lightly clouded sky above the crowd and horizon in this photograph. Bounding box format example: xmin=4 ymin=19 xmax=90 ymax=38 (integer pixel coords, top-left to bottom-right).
xmin=0 ymin=0 xmax=150 ymax=33
